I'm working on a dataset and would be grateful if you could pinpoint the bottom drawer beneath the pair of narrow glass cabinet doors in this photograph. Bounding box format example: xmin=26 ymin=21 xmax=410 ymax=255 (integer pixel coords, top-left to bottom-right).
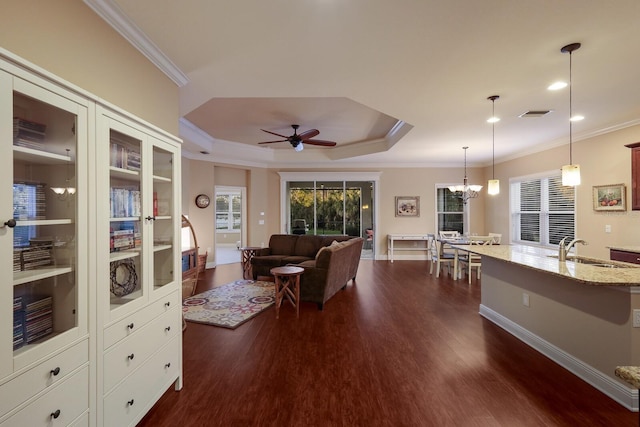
xmin=104 ymin=337 xmax=182 ymax=427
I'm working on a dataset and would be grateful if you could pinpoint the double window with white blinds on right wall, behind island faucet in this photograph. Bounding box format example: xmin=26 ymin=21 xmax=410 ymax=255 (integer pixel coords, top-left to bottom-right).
xmin=510 ymin=174 xmax=575 ymax=246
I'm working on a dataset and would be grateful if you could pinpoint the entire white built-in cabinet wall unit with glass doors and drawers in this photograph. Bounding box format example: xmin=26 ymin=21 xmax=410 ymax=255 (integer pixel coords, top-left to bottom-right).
xmin=0 ymin=49 xmax=182 ymax=427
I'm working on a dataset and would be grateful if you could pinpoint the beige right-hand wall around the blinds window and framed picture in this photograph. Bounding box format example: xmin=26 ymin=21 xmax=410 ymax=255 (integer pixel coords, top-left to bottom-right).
xmin=484 ymin=122 xmax=640 ymax=259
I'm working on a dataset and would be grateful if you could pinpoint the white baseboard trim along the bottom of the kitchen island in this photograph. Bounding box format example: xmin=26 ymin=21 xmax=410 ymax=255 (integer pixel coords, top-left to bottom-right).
xmin=479 ymin=304 xmax=638 ymax=412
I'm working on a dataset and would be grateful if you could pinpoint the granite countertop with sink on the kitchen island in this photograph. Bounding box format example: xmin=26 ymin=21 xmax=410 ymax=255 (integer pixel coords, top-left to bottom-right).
xmin=451 ymin=244 xmax=640 ymax=286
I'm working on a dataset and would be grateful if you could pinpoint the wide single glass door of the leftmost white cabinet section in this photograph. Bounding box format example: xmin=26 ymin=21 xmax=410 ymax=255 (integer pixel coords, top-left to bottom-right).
xmin=0 ymin=71 xmax=88 ymax=370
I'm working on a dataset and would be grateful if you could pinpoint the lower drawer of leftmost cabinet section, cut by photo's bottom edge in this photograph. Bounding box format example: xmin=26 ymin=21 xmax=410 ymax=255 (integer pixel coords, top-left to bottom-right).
xmin=0 ymin=367 xmax=89 ymax=427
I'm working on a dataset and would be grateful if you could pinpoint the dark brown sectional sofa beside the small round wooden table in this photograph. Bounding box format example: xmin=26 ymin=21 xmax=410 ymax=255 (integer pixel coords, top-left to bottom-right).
xmin=251 ymin=234 xmax=364 ymax=310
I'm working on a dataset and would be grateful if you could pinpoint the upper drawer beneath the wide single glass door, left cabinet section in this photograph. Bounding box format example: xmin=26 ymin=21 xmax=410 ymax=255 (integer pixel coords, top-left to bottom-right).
xmin=0 ymin=340 xmax=89 ymax=415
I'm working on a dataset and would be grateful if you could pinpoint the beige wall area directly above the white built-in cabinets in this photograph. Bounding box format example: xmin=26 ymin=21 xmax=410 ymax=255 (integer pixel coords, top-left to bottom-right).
xmin=0 ymin=0 xmax=179 ymax=135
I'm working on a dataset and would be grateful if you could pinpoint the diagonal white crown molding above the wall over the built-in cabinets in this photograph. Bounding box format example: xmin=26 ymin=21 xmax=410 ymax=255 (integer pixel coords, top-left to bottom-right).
xmin=84 ymin=0 xmax=189 ymax=87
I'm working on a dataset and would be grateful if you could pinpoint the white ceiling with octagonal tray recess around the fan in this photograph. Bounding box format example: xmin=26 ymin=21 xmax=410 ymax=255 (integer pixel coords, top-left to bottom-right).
xmin=85 ymin=0 xmax=640 ymax=171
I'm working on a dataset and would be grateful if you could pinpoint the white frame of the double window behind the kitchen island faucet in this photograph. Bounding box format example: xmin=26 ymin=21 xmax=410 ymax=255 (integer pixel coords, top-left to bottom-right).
xmin=509 ymin=170 xmax=577 ymax=248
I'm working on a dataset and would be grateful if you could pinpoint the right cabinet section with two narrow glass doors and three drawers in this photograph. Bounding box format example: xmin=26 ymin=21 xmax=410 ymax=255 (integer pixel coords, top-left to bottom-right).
xmin=96 ymin=107 xmax=182 ymax=426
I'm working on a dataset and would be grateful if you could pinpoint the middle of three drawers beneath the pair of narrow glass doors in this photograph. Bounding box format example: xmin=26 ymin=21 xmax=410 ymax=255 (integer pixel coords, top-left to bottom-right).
xmin=104 ymin=307 xmax=182 ymax=393
